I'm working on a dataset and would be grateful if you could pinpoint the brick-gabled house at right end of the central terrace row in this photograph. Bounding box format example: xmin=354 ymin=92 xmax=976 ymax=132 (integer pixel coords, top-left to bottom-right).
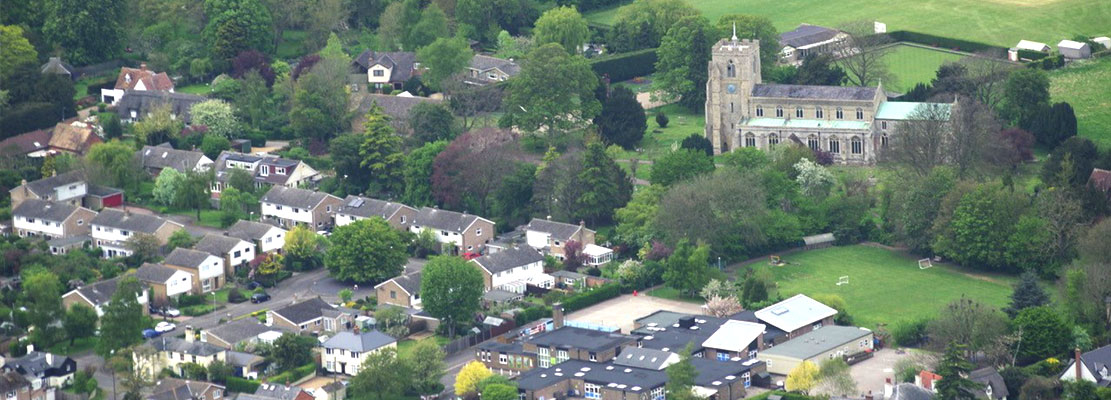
xmin=409 ymin=207 xmax=494 ymax=253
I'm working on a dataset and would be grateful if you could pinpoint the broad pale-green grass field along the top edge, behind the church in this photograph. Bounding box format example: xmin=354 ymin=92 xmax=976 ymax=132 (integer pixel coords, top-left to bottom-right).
xmin=587 ymin=0 xmax=1111 ymax=47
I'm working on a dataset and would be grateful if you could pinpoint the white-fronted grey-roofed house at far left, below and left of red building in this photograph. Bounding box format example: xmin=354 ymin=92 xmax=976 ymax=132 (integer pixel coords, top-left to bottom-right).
xmin=11 ymin=199 xmax=97 ymax=240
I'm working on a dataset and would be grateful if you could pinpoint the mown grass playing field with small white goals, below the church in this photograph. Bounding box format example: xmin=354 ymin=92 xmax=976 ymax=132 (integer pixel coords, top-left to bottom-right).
xmin=760 ymin=244 xmax=1014 ymax=328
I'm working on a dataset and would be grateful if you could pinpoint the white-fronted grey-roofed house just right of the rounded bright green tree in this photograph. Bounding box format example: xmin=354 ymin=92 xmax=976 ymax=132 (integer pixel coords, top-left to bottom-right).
xmin=471 ymin=247 xmax=554 ymax=293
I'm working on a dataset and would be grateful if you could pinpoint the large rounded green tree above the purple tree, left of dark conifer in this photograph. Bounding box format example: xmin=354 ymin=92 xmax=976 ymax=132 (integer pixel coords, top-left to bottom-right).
xmin=499 ymin=43 xmax=601 ymax=134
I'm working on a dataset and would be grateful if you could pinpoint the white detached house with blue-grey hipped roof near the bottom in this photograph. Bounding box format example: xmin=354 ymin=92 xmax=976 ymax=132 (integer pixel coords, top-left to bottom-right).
xmin=320 ymin=329 xmax=398 ymax=377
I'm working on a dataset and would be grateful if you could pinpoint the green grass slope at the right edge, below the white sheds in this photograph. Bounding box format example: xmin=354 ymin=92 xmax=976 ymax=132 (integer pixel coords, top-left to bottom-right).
xmin=1050 ymin=58 xmax=1111 ymax=149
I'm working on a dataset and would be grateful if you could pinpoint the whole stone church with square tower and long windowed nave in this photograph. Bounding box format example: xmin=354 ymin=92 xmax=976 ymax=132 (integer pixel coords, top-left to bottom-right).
xmin=705 ymin=32 xmax=952 ymax=166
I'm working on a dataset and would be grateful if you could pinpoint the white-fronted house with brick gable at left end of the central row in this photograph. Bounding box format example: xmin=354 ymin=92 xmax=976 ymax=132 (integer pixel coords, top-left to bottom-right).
xmin=259 ymin=186 xmax=343 ymax=230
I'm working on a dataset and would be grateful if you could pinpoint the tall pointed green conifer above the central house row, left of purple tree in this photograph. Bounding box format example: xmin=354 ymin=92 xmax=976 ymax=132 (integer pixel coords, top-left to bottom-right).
xmin=359 ymin=107 xmax=406 ymax=192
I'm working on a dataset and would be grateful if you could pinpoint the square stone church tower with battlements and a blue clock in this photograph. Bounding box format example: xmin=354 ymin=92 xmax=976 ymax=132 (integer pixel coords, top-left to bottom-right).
xmin=705 ymin=24 xmax=761 ymax=154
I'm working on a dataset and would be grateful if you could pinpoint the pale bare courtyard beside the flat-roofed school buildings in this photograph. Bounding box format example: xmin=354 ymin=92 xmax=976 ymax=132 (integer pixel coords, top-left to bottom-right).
xmin=567 ymin=294 xmax=702 ymax=332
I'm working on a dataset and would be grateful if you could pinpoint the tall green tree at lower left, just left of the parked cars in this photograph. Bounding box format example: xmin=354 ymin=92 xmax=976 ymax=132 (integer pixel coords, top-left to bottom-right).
xmin=97 ymin=277 xmax=143 ymax=358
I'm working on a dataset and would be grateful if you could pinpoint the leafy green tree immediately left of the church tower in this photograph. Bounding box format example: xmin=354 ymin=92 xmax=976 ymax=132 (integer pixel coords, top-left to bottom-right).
xmin=653 ymin=16 xmax=720 ymax=111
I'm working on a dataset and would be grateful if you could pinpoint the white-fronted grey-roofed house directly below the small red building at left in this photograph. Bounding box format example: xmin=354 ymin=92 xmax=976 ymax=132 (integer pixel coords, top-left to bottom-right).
xmin=90 ymin=209 xmax=184 ymax=258
